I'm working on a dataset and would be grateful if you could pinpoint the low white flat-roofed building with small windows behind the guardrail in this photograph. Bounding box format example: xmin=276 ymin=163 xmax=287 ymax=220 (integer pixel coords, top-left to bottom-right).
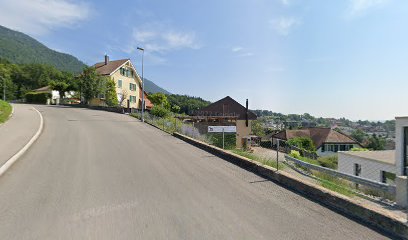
xmin=338 ymin=150 xmax=397 ymax=185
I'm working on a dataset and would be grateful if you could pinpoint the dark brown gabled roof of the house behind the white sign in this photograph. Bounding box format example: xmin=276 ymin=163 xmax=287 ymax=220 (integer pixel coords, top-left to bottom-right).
xmin=194 ymin=96 xmax=257 ymax=120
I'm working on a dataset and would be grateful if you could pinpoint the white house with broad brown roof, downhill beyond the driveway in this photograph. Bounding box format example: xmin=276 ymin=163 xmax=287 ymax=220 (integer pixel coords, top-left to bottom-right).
xmin=272 ymin=128 xmax=361 ymax=156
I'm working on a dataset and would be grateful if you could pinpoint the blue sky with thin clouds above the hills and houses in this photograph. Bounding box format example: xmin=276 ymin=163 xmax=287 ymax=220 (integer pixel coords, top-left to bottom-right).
xmin=0 ymin=0 xmax=408 ymax=120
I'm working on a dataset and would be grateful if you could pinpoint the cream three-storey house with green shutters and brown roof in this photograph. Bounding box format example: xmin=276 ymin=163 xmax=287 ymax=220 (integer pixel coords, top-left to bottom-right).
xmin=94 ymin=55 xmax=142 ymax=109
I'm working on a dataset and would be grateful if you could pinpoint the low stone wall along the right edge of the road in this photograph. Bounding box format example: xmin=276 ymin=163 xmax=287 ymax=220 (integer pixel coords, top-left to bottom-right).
xmin=173 ymin=133 xmax=408 ymax=239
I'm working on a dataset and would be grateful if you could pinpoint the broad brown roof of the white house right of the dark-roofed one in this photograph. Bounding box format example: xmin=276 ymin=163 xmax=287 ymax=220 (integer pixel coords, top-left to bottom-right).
xmin=272 ymin=128 xmax=359 ymax=148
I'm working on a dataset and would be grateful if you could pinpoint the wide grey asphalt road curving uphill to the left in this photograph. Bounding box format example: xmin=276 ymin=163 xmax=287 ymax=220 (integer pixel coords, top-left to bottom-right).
xmin=0 ymin=106 xmax=386 ymax=240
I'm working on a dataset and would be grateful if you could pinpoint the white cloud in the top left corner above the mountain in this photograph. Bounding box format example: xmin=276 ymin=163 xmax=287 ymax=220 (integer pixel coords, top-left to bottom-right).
xmin=0 ymin=0 xmax=90 ymax=35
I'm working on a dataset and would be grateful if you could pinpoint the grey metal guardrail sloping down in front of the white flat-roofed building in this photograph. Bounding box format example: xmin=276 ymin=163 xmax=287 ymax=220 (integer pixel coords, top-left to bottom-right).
xmin=285 ymin=155 xmax=396 ymax=195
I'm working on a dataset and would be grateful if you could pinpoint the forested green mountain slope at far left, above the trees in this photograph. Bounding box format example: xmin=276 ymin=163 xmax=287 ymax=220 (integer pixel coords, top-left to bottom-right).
xmin=0 ymin=26 xmax=85 ymax=73
